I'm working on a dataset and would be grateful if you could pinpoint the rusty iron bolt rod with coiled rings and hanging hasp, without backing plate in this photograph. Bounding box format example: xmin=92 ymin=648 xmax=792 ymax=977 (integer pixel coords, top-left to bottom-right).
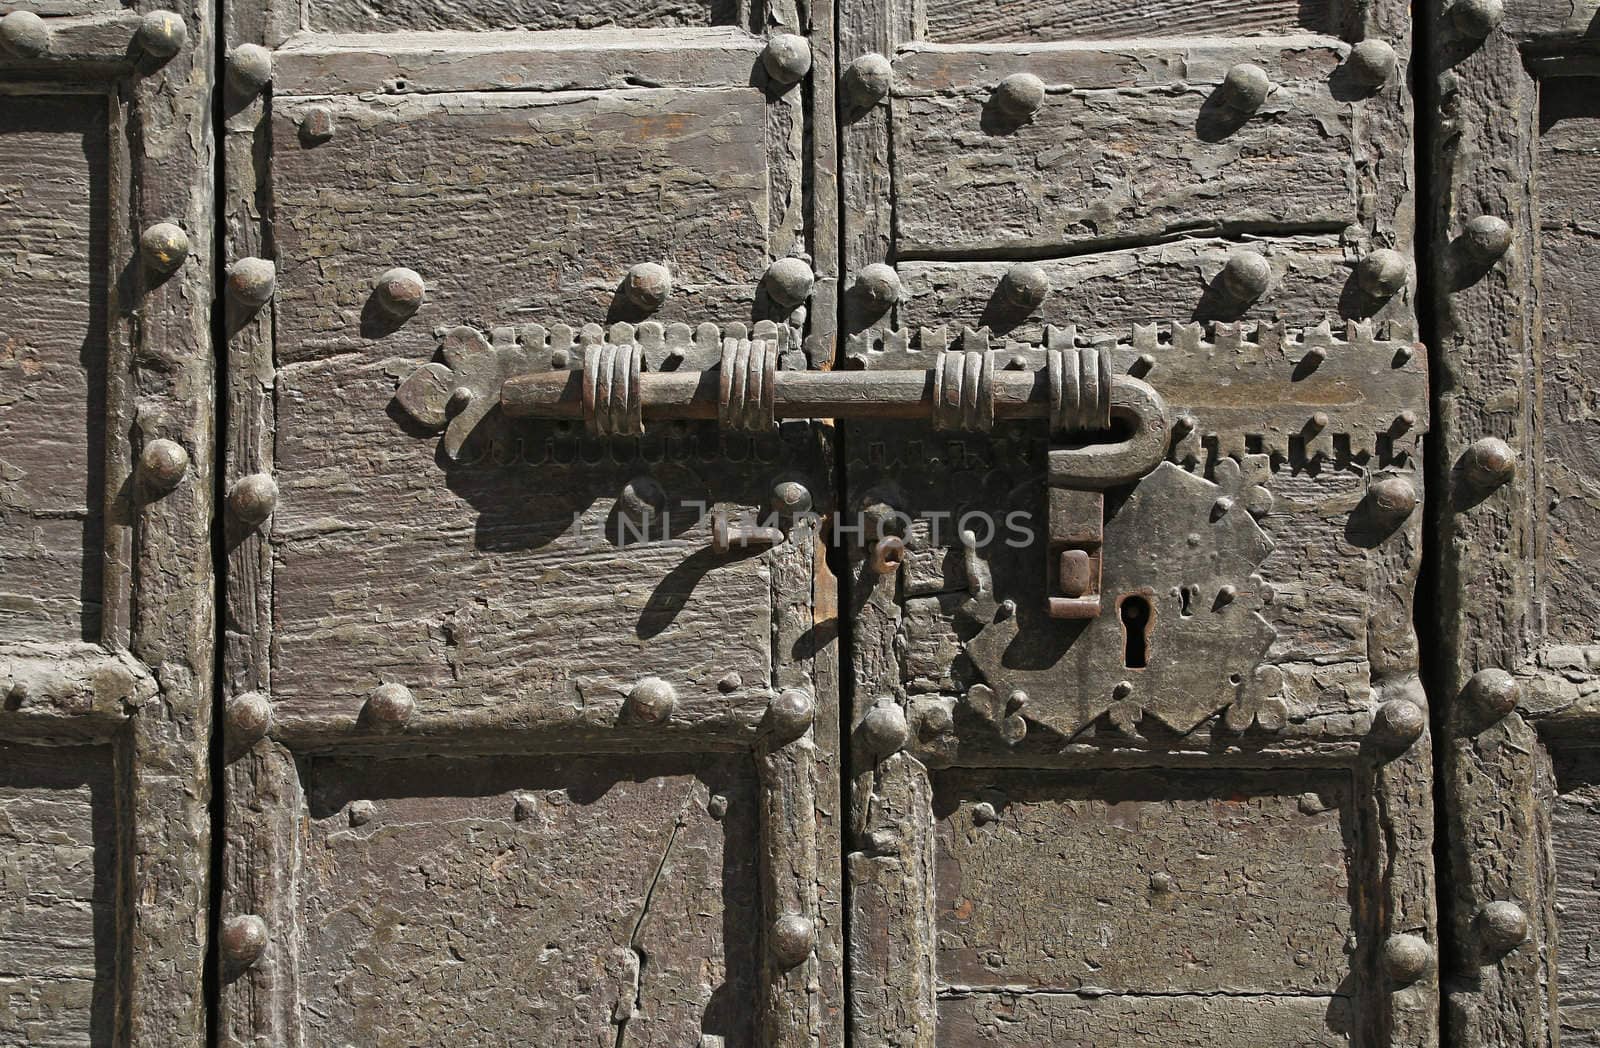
xmin=499 ymin=329 xmax=1168 ymax=619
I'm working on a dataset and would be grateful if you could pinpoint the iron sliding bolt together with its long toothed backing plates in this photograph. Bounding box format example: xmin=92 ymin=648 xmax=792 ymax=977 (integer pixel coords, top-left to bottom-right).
xmin=395 ymin=322 xmax=1427 ymax=619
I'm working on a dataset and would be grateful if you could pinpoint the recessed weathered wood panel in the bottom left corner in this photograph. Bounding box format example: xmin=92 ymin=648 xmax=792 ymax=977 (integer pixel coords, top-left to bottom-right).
xmin=0 ymin=742 xmax=118 ymax=1048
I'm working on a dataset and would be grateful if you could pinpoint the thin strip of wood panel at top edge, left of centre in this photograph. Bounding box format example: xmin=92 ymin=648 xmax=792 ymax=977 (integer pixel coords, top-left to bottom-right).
xmin=306 ymin=0 xmax=744 ymax=32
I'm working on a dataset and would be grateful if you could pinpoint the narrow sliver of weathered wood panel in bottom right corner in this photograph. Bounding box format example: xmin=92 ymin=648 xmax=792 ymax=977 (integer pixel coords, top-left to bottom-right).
xmin=1550 ymin=750 xmax=1600 ymax=1048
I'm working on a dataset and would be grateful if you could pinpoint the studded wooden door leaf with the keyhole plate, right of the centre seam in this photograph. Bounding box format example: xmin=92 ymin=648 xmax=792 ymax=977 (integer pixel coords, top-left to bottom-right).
xmin=838 ymin=0 xmax=1438 ymax=1048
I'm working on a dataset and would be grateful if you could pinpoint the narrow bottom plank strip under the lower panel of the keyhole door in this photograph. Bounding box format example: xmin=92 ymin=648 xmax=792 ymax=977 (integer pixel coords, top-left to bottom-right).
xmin=939 ymin=994 xmax=1355 ymax=1048
